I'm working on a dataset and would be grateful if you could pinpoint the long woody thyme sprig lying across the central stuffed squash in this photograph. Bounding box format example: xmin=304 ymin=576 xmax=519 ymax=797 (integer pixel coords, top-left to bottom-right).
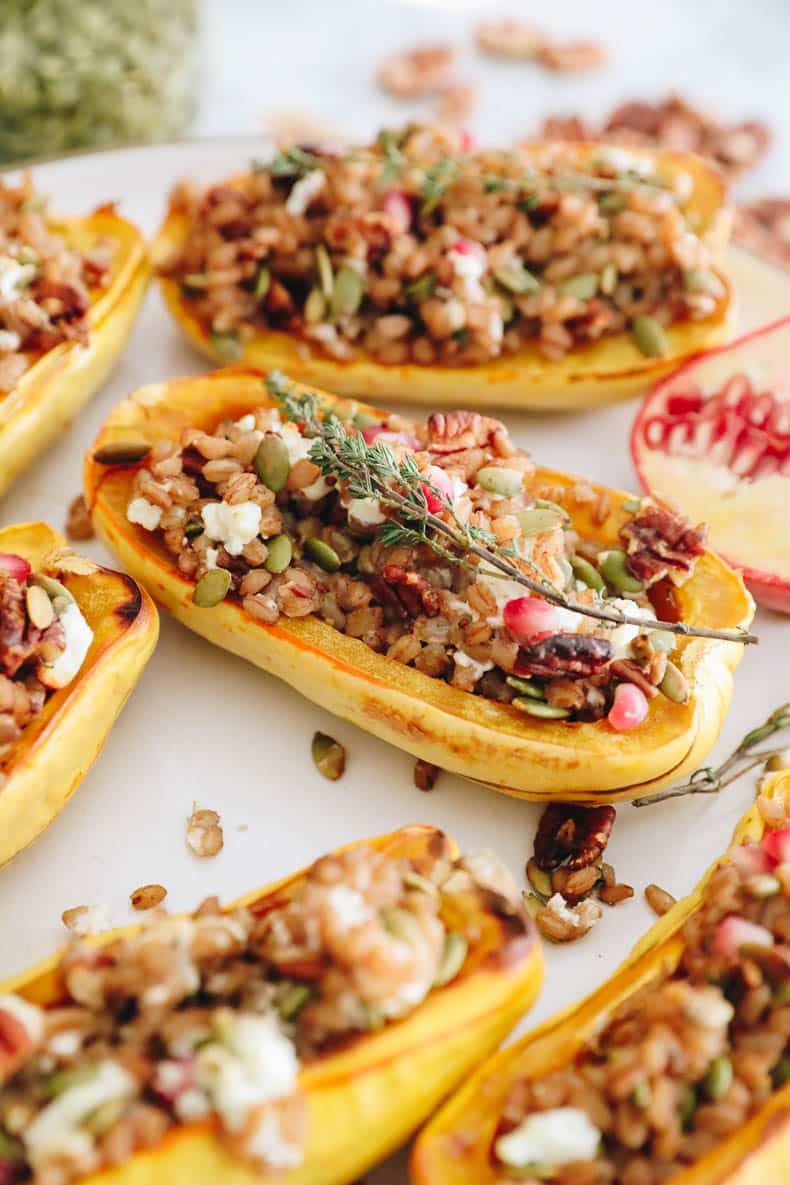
xmin=265 ymin=371 xmax=758 ymax=643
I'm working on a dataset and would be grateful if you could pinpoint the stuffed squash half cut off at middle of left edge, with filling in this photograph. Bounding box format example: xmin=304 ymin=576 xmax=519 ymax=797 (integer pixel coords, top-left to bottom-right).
xmin=0 ymin=523 xmax=159 ymax=867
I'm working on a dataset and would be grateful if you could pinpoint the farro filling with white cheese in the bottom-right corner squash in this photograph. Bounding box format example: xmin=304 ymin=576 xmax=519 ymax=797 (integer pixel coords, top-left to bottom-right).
xmin=492 ymin=819 xmax=790 ymax=1185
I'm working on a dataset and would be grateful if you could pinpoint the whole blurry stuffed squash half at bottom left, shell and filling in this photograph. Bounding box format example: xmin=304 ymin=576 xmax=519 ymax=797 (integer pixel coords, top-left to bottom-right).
xmin=0 ymin=827 xmax=542 ymax=1185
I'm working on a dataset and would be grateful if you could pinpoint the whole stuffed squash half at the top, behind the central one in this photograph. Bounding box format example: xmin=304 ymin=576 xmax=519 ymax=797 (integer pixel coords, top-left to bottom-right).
xmin=154 ymin=126 xmax=732 ymax=410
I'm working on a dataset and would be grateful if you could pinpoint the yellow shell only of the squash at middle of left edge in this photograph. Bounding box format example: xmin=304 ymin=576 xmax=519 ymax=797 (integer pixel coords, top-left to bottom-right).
xmin=0 ymin=523 xmax=159 ymax=865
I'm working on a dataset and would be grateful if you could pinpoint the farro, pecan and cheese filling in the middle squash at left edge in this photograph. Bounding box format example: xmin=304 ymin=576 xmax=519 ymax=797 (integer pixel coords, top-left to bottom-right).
xmin=0 ymin=553 xmax=94 ymax=770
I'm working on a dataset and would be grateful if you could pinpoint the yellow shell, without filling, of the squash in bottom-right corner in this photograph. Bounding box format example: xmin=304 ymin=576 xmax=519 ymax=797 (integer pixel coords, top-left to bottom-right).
xmin=411 ymin=770 xmax=790 ymax=1185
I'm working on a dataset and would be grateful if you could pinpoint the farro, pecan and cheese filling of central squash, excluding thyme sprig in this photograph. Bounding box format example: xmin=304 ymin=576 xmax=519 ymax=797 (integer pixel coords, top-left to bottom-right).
xmin=127 ymin=393 xmax=704 ymax=729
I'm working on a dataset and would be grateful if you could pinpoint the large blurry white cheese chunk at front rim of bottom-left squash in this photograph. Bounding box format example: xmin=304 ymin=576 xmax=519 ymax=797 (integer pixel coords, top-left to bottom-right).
xmin=198 ymin=1011 xmax=298 ymax=1132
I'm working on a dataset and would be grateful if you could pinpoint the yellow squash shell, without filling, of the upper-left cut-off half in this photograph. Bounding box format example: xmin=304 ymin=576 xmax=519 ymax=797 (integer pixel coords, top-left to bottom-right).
xmin=0 ymin=207 xmax=150 ymax=497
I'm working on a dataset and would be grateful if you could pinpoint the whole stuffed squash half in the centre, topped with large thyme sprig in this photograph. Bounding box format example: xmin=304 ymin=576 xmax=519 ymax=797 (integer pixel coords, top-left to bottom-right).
xmin=85 ymin=371 xmax=753 ymax=801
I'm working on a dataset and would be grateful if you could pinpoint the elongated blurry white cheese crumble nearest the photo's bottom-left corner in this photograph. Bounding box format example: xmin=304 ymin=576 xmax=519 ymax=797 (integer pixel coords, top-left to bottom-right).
xmin=23 ymin=1062 xmax=136 ymax=1173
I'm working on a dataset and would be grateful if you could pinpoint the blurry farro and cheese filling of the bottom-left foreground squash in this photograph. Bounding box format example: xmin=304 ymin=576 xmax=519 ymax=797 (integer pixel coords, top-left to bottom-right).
xmin=0 ymin=844 xmax=518 ymax=1185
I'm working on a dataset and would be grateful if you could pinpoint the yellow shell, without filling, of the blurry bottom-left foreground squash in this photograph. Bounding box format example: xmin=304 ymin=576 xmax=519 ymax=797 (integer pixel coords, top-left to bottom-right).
xmin=0 ymin=826 xmax=542 ymax=1185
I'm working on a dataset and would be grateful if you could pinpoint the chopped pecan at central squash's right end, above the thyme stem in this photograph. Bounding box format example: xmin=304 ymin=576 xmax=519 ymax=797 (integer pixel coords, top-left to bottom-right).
xmin=619 ymin=504 xmax=706 ymax=584
